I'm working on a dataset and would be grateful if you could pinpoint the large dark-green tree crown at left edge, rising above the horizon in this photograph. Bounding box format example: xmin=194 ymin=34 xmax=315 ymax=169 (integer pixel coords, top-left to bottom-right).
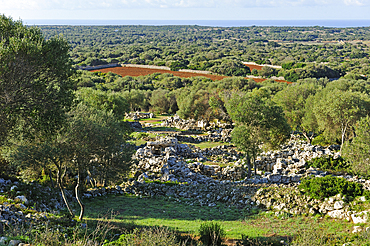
xmin=0 ymin=15 xmax=73 ymax=146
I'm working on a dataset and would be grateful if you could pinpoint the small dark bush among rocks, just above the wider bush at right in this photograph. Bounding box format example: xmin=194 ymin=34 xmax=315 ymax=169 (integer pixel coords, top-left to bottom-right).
xmin=307 ymin=156 xmax=350 ymax=172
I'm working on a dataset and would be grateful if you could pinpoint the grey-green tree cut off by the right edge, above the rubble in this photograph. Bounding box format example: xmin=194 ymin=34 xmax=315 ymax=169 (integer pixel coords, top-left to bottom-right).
xmin=342 ymin=116 xmax=370 ymax=176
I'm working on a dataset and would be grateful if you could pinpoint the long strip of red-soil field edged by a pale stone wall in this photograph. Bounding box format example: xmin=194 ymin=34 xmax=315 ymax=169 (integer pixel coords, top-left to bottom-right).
xmin=91 ymin=67 xmax=290 ymax=83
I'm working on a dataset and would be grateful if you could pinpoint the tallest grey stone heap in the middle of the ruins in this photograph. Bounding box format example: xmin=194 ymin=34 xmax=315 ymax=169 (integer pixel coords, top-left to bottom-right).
xmin=132 ymin=137 xmax=245 ymax=184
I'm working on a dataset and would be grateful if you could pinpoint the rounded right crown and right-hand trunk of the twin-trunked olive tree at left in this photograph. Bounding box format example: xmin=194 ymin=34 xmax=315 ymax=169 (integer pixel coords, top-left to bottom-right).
xmin=61 ymin=104 xmax=132 ymax=219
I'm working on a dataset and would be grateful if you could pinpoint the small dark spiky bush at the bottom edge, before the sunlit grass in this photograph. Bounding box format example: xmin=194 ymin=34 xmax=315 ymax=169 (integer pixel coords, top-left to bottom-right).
xmin=199 ymin=222 xmax=226 ymax=246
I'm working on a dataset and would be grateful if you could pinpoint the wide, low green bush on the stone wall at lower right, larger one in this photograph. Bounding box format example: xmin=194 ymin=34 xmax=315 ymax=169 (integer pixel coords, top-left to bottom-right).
xmin=299 ymin=176 xmax=366 ymax=200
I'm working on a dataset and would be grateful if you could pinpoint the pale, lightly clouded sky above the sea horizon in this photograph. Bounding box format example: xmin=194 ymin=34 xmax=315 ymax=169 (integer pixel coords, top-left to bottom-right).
xmin=0 ymin=0 xmax=370 ymax=20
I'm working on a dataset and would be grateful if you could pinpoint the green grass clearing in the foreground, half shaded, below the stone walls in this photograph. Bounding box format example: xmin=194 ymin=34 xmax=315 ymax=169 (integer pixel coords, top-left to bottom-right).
xmin=81 ymin=196 xmax=353 ymax=239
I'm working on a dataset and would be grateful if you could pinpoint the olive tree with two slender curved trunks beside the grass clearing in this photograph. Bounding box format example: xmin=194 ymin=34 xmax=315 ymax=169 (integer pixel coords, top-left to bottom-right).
xmin=7 ymin=103 xmax=133 ymax=219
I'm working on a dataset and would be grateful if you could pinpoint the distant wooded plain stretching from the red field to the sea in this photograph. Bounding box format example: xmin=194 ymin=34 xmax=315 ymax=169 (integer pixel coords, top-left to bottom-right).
xmin=41 ymin=26 xmax=370 ymax=81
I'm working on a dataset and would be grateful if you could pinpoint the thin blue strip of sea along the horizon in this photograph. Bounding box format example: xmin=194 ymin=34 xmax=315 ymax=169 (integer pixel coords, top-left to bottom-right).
xmin=23 ymin=19 xmax=370 ymax=27
